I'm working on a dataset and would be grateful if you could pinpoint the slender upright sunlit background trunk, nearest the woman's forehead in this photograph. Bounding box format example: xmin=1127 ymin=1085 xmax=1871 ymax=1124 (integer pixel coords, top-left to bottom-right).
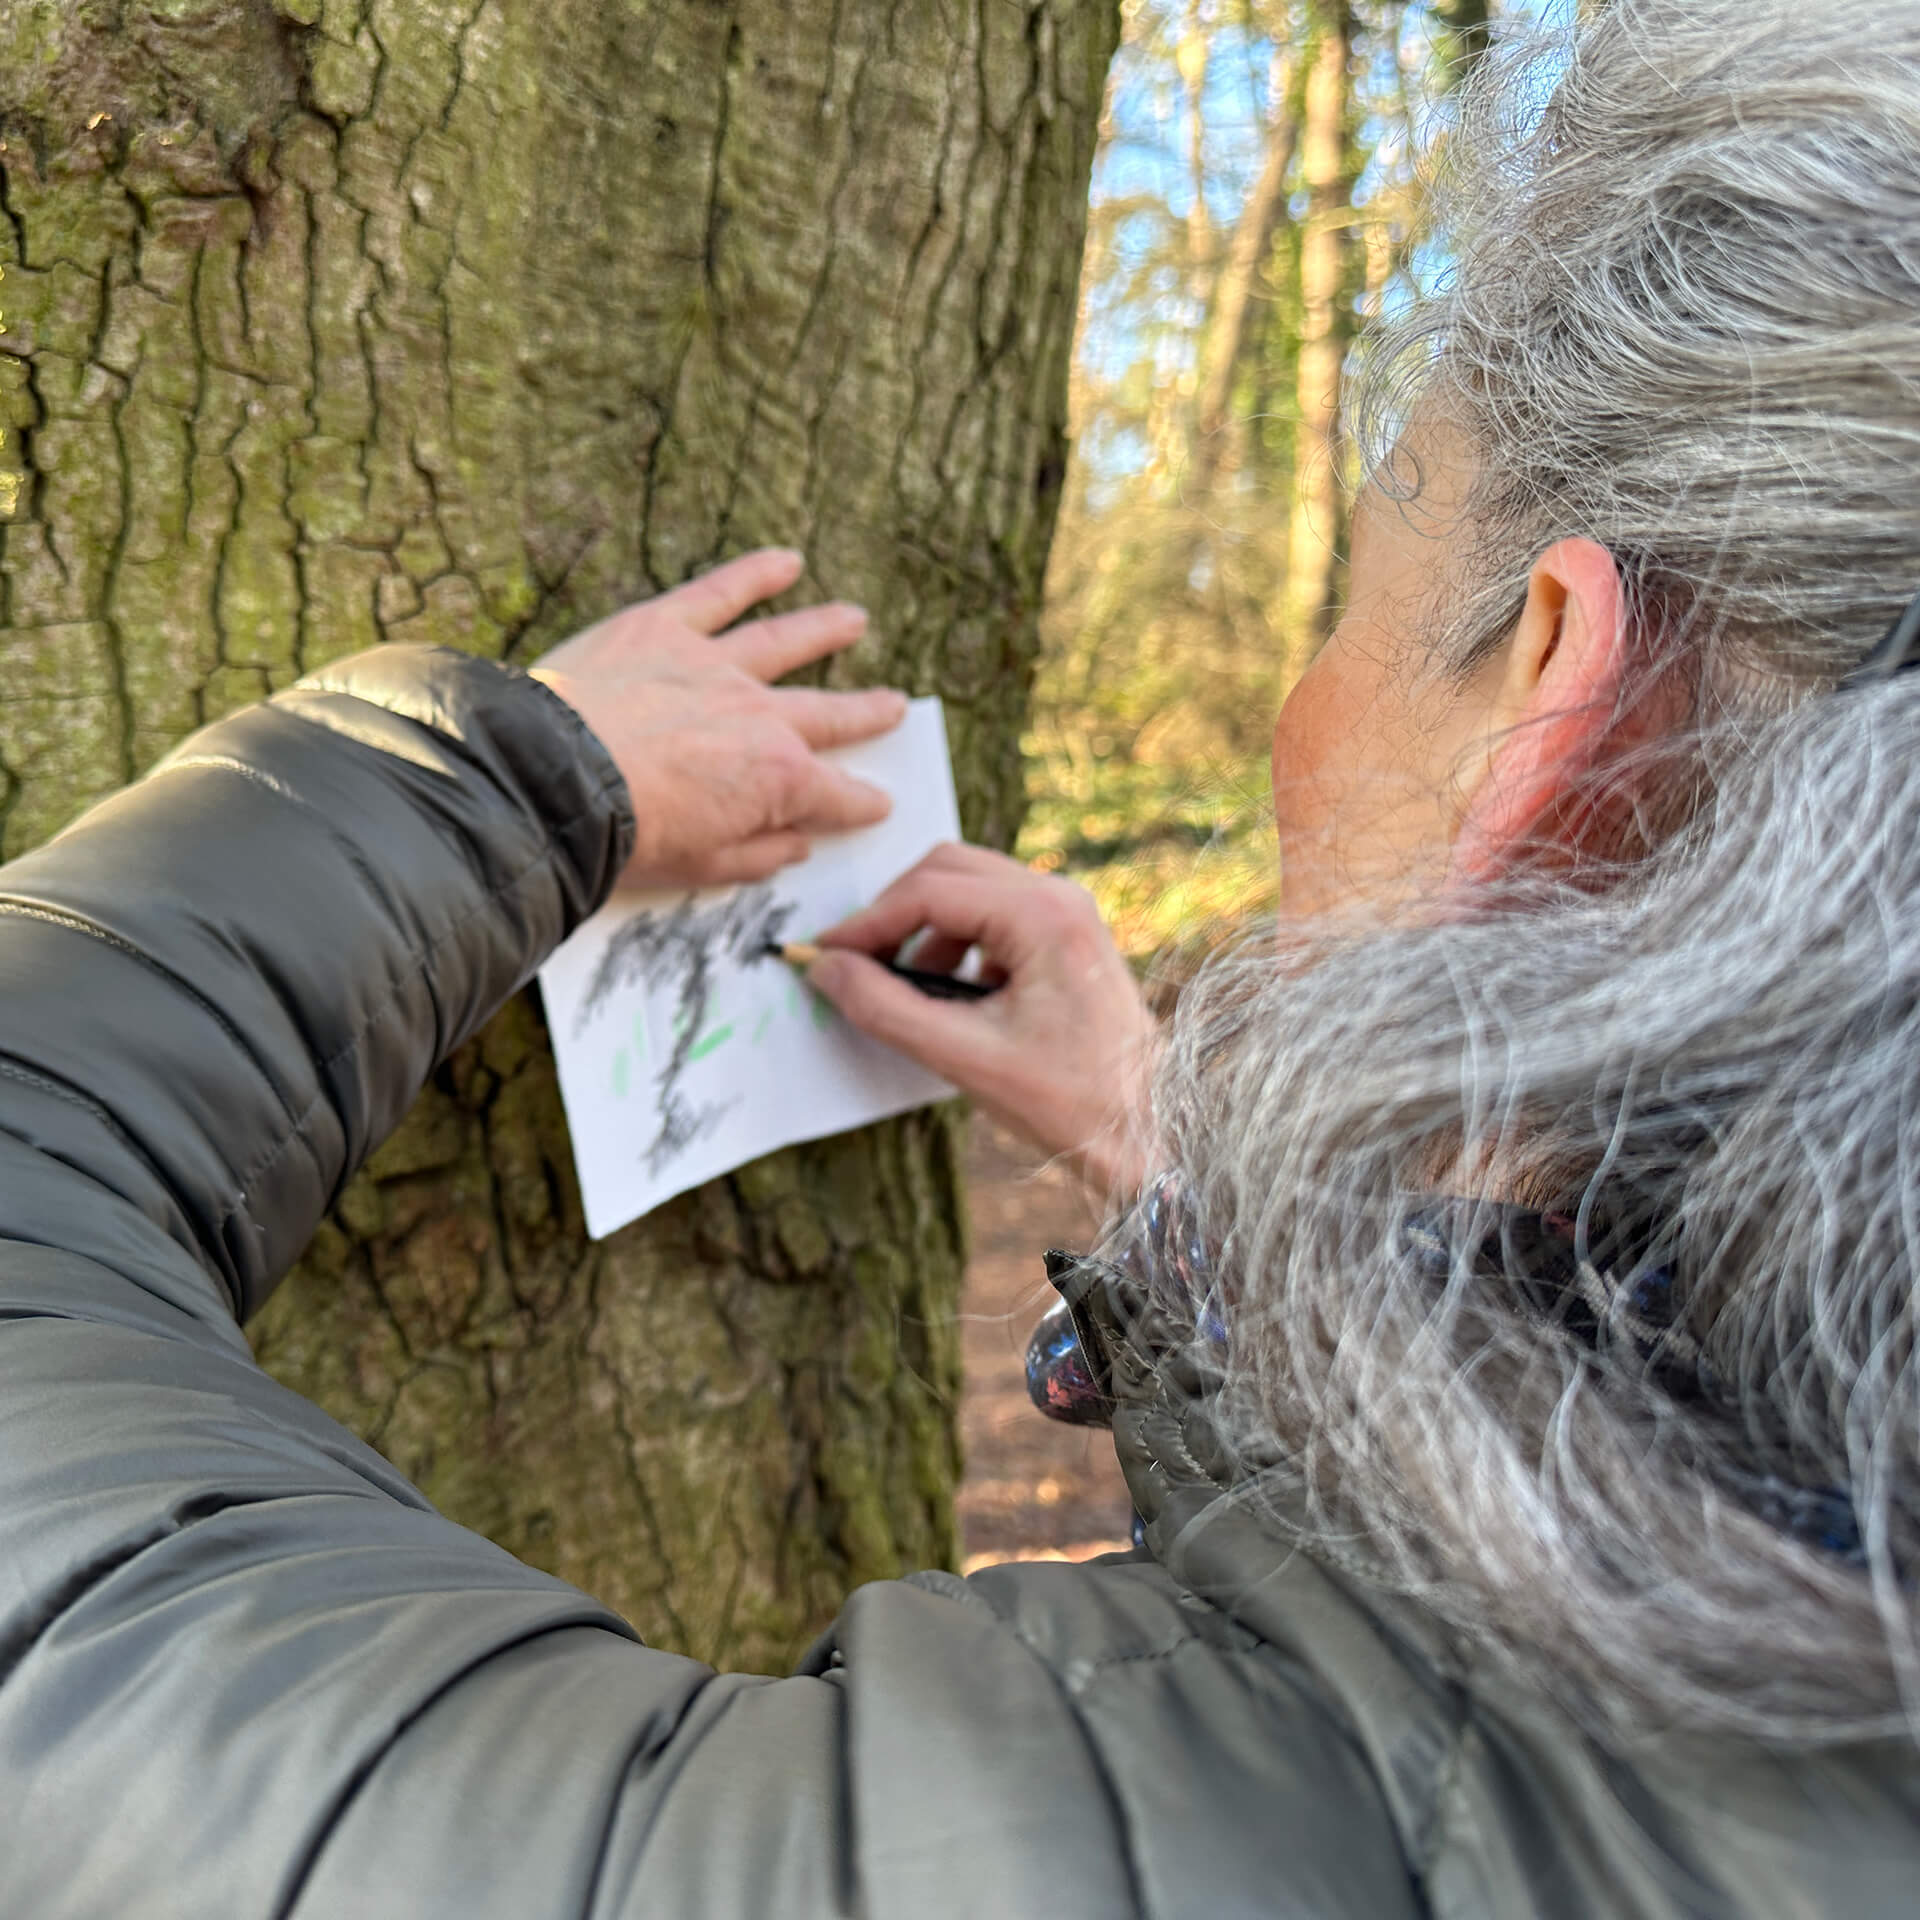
xmin=1286 ymin=0 xmax=1352 ymax=664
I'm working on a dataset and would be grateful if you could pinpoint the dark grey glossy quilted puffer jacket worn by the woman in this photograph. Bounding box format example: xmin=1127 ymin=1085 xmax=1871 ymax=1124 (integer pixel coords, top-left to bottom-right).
xmin=0 ymin=649 xmax=1920 ymax=1920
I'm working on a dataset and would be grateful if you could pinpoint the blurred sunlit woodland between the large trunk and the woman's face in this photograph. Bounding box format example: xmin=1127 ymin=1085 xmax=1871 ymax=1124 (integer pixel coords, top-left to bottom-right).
xmin=1021 ymin=0 xmax=1500 ymax=956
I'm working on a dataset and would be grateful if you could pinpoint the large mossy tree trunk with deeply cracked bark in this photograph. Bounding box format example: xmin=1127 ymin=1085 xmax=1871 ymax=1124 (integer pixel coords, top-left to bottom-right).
xmin=0 ymin=0 xmax=1117 ymax=1665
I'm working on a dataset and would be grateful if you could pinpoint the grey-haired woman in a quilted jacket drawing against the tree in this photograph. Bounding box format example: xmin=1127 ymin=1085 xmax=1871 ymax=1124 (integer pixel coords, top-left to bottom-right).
xmin=0 ymin=0 xmax=1920 ymax=1920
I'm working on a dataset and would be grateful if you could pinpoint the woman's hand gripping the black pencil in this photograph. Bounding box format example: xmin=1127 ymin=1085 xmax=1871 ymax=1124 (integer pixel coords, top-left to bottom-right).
xmin=808 ymin=847 xmax=1156 ymax=1196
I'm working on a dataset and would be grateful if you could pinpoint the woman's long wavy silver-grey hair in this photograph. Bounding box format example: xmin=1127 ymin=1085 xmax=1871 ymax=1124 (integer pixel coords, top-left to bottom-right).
xmin=1156 ymin=0 xmax=1920 ymax=1743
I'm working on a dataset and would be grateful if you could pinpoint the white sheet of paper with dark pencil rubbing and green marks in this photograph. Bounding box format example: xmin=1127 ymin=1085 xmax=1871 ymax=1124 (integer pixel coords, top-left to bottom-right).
xmin=540 ymin=699 xmax=960 ymax=1240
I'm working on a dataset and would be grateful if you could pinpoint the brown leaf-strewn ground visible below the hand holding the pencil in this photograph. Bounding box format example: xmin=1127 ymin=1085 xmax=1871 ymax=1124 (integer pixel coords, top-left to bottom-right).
xmin=960 ymin=1116 xmax=1131 ymax=1572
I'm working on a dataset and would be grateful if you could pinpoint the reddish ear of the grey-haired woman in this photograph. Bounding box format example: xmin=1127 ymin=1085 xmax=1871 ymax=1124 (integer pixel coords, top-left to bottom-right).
xmin=1448 ymin=540 xmax=1626 ymax=885
